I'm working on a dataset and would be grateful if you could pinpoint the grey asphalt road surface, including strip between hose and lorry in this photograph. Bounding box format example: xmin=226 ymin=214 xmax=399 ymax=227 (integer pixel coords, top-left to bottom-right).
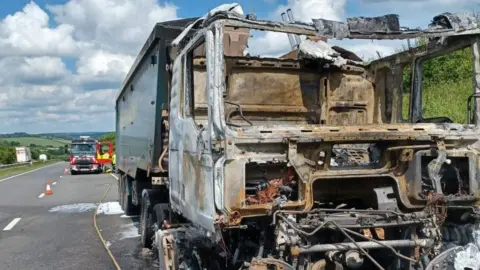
xmin=0 ymin=162 xmax=155 ymax=269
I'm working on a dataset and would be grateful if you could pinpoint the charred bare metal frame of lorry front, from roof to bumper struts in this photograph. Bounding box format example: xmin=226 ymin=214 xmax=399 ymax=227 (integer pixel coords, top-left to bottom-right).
xmin=153 ymin=7 xmax=480 ymax=269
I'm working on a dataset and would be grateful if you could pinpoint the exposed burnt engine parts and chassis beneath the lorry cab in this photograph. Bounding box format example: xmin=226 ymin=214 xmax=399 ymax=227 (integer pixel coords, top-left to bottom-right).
xmin=151 ymin=145 xmax=480 ymax=270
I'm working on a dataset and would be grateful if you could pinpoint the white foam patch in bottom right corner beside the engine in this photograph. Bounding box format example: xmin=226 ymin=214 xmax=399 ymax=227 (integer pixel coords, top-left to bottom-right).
xmin=455 ymin=226 xmax=480 ymax=270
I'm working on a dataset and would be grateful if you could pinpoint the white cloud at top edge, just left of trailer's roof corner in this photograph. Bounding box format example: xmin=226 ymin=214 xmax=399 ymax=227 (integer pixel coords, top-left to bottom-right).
xmin=47 ymin=0 xmax=177 ymax=54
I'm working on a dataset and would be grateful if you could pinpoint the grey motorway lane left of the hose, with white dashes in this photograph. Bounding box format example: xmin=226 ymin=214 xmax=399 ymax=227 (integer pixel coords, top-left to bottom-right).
xmin=0 ymin=163 xmax=116 ymax=269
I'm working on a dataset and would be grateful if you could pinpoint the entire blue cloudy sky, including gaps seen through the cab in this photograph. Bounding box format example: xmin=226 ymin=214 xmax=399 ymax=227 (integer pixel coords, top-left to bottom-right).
xmin=0 ymin=0 xmax=480 ymax=133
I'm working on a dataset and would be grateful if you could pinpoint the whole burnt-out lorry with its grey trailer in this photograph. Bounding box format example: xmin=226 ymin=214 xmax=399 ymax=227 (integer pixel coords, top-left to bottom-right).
xmin=116 ymin=4 xmax=480 ymax=270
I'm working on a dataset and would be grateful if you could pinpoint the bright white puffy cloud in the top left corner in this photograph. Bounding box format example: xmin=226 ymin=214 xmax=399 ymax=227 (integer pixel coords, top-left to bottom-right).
xmin=0 ymin=2 xmax=89 ymax=56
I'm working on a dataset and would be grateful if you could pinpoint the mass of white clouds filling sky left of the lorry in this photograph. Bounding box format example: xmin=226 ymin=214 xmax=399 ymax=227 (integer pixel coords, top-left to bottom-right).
xmin=0 ymin=0 xmax=177 ymax=132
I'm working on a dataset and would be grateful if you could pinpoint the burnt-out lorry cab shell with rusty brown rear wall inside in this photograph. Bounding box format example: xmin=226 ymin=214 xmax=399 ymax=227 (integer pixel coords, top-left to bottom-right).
xmin=169 ymin=9 xmax=480 ymax=232
